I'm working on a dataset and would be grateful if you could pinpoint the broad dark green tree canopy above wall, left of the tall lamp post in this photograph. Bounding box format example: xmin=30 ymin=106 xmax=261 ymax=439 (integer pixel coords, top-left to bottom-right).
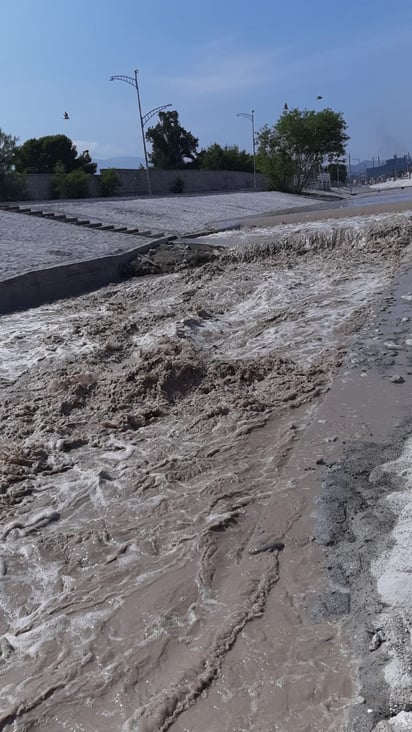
xmin=15 ymin=135 xmax=97 ymax=173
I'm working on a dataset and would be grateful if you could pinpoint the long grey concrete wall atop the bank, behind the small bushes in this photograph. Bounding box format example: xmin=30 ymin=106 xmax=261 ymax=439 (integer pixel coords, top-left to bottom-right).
xmin=25 ymin=169 xmax=268 ymax=201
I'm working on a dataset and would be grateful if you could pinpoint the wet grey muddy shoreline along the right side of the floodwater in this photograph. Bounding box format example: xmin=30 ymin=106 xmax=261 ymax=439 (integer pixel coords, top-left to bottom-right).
xmin=314 ymin=268 xmax=412 ymax=732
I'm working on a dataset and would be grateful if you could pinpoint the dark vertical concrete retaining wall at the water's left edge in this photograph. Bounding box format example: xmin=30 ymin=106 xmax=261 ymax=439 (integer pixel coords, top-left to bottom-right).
xmin=0 ymin=240 xmax=159 ymax=315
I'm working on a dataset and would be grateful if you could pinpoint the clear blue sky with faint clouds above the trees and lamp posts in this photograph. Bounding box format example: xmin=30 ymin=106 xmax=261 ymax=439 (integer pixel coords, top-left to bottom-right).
xmin=0 ymin=0 xmax=412 ymax=161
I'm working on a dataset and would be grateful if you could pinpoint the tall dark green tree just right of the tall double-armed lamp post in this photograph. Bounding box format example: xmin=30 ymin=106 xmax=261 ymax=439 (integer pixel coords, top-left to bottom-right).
xmin=146 ymin=111 xmax=199 ymax=170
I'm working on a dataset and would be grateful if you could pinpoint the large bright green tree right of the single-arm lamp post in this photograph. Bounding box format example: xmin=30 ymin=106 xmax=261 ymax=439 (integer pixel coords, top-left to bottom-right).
xmin=258 ymin=109 xmax=349 ymax=193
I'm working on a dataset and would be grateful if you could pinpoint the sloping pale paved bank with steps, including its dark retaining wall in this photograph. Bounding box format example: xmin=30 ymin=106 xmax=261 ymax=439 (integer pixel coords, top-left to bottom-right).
xmin=0 ymin=192 xmax=320 ymax=313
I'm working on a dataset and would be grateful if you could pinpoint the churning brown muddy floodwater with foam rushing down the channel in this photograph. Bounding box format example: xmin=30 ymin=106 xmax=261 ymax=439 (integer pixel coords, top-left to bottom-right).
xmin=0 ymin=216 xmax=412 ymax=732
